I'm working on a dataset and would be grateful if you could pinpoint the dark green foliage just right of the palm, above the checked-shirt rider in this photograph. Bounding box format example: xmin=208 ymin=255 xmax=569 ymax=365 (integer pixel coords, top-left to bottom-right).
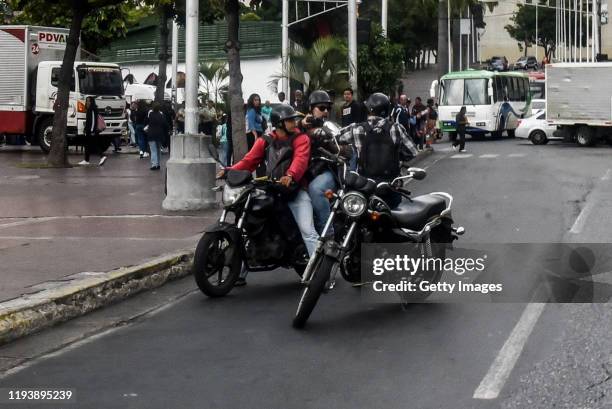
xmin=357 ymin=24 xmax=403 ymax=96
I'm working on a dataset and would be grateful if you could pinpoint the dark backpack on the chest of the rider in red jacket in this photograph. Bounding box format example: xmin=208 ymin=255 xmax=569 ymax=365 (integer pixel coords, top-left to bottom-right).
xmin=261 ymin=134 xmax=299 ymax=196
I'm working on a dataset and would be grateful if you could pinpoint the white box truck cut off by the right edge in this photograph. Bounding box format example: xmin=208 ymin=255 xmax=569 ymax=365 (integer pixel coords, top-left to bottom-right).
xmin=546 ymin=62 xmax=612 ymax=146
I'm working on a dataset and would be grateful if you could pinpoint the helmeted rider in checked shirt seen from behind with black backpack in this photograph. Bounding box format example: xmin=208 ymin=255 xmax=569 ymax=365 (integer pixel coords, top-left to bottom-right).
xmin=340 ymin=92 xmax=417 ymax=208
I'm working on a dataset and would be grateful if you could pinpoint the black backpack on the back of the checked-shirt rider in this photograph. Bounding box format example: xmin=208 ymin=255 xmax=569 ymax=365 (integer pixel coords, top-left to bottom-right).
xmin=359 ymin=121 xmax=401 ymax=181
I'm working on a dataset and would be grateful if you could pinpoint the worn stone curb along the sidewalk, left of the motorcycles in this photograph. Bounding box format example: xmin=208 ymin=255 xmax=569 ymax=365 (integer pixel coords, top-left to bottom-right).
xmin=0 ymin=250 xmax=194 ymax=345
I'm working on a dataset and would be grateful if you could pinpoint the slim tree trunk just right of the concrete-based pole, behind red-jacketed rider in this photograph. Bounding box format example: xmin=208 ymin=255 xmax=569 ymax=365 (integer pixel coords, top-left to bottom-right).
xmin=225 ymin=0 xmax=247 ymax=162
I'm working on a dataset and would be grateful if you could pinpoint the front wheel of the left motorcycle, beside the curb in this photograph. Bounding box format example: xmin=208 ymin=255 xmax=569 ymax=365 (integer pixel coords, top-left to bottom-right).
xmin=193 ymin=231 xmax=242 ymax=297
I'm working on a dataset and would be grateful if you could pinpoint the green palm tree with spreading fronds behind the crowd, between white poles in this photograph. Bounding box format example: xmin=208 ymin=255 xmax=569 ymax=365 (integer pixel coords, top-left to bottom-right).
xmin=269 ymin=37 xmax=349 ymax=94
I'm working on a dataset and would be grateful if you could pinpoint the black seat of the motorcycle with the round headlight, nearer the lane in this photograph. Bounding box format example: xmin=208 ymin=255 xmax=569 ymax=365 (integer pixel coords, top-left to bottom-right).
xmin=391 ymin=195 xmax=446 ymax=231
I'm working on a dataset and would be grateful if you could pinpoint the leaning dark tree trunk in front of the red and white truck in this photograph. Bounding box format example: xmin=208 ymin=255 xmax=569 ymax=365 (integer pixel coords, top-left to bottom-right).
xmin=47 ymin=0 xmax=88 ymax=168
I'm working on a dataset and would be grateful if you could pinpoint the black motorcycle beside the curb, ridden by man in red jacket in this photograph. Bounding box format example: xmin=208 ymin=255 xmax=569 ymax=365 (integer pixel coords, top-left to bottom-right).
xmin=193 ymin=145 xmax=308 ymax=297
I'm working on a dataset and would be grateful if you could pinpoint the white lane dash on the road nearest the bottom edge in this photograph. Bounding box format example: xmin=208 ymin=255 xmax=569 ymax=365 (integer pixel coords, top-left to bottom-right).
xmin=473 ymin=303 xmax=546 ymax=399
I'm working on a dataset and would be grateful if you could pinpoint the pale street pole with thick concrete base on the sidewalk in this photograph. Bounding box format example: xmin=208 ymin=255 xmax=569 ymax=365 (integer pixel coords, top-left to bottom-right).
xmin=162 ymin=0 xmax=217 ymax=211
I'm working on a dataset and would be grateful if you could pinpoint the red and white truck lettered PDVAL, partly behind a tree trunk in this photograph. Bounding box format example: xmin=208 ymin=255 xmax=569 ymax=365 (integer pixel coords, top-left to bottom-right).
xmin=0 ymin=26 xmax=127 ymax=152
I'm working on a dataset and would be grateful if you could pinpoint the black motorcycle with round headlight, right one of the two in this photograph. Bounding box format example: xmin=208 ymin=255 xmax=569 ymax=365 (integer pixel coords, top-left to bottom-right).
xmin=293 ymin=155 xmax=464 ymax=328
